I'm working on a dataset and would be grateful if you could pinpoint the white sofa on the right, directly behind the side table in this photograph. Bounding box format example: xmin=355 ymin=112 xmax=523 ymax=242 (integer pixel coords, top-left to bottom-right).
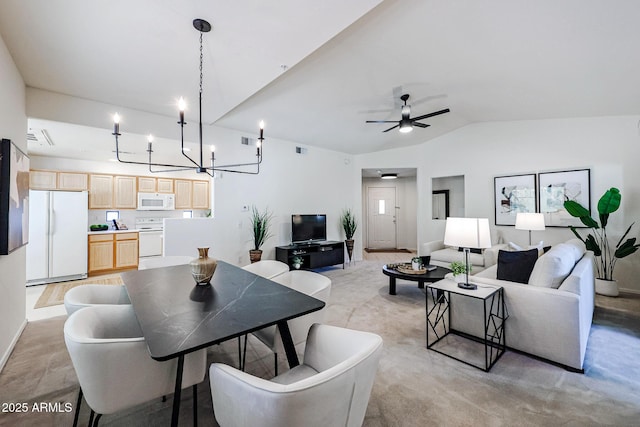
xmin=444 ymin=239 xmax=595 ymax=372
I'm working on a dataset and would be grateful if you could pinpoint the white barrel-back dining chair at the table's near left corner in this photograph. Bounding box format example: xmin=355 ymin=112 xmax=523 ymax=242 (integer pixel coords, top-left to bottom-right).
xmin=64 ymin=305 xmax=207 ymax=426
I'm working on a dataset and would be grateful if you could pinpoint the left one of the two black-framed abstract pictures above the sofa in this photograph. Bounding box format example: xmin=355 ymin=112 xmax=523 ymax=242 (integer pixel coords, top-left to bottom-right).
xmin=494 ymin=174 xmax=537 ymax=225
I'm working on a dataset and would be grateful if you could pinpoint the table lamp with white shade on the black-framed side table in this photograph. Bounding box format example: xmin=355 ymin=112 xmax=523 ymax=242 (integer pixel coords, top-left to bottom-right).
xmin=444 ymin=218 xmax=491 ymax=289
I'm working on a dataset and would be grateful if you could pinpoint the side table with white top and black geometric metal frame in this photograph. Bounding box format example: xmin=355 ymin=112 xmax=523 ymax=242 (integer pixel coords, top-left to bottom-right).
xmin=425 ymin=279 xmax=508 ymax=372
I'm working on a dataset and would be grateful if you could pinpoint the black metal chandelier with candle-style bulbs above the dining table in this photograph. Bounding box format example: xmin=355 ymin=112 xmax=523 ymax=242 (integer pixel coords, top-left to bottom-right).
xmin=112 ymin=19 xmax=264 ymax=177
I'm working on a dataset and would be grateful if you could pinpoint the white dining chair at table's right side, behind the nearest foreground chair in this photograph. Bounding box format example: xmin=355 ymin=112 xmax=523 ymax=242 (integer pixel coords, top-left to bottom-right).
xmin=241 ymin=270 xmax=331 ymax=375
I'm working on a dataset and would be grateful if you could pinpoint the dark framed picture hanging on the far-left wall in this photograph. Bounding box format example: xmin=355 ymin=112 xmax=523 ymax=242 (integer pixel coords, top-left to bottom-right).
xmin=0 ymin=139 xmax=29 ymax=255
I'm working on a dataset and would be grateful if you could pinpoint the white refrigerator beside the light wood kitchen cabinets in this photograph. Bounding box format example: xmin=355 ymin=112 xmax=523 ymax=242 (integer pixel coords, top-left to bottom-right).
xmin=27 ymin=190 xmax=89 ymax=285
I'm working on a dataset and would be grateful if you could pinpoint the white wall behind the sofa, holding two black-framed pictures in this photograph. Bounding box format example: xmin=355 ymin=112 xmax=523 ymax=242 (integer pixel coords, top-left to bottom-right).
xmin=354 ymin=116 xmax=640 ymax=293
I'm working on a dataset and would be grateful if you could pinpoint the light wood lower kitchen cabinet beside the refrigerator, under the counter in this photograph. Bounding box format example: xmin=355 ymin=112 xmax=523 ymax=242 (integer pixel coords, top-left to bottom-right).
xmin=88 ymin=232 xmax=138 ymax=276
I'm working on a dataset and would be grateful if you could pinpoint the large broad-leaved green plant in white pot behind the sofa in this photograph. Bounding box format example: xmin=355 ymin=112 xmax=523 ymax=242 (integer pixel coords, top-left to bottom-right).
xmin=564 ymin=187 xmax=640 ymax=296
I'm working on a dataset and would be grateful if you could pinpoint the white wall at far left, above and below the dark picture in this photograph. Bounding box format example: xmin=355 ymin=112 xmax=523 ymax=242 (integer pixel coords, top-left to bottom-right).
xmin=0 ymin=33 xmax=27 ymax=370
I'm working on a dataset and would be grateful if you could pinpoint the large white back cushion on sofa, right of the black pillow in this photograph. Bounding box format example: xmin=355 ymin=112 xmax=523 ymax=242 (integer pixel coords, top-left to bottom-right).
xmin=529 ymin=239 xmax=584 ymax=289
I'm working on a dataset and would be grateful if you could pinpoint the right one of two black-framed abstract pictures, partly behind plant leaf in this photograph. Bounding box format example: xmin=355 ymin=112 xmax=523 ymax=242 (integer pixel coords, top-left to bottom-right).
xmin=538 ymin=169 xmax=591 ymax=227
